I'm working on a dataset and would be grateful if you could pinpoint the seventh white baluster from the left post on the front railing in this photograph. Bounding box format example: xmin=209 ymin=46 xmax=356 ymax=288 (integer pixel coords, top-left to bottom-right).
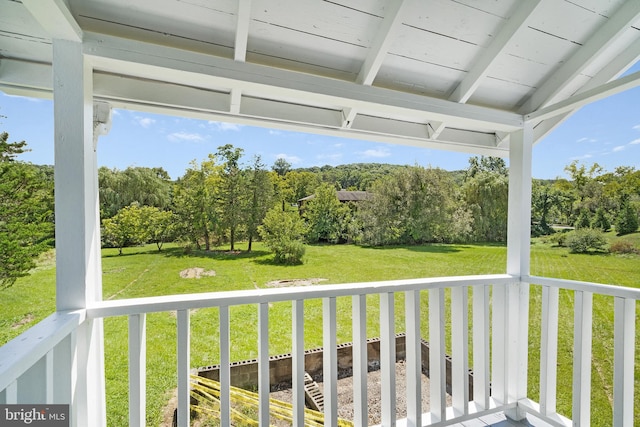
xmin=352 ymin=295 xmax=369 ymax=426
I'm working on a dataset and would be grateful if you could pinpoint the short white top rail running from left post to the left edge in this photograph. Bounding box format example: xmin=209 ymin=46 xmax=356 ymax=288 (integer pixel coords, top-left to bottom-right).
xmin=0 ymin=310 xmax=86 ymax=390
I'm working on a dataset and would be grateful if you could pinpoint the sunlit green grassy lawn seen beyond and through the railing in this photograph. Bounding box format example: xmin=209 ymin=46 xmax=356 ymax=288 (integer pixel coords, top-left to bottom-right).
xmin=0 ymin=239 xmax=640 ymax=426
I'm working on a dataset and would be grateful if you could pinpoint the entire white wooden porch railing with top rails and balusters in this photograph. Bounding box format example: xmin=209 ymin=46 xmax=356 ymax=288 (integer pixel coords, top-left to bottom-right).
xmin=0 ymin=275 xmax=640 ymax=426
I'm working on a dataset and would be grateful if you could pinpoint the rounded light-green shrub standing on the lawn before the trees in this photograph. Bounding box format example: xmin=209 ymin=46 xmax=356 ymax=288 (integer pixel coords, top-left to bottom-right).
xmin=258 ymin=207 xmax=306 ymax=264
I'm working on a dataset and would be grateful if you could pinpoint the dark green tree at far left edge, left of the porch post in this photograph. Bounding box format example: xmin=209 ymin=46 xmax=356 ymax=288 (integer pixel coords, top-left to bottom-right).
xmin=0 ymin=132 xmax=53 ymax=289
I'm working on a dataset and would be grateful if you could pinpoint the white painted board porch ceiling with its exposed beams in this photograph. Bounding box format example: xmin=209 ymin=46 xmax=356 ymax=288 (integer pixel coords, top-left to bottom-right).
xmin=0 ymin=0 xmax=640 ymax=155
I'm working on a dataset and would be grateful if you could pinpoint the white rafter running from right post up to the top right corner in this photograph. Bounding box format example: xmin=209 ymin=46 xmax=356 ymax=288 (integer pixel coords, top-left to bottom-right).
xmin=520 ymin=0 xmax=640 ymax=114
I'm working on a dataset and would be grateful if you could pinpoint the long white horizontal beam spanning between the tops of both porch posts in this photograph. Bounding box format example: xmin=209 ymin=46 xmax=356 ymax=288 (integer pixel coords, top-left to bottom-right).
xmin=84 ymin=33 xmax=523 ymax=132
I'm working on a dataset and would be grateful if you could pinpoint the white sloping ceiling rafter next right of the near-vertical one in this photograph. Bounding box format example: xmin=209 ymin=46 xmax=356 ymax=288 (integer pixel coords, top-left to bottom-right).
xmin=356 ymin=0 xmax=404 ymax=85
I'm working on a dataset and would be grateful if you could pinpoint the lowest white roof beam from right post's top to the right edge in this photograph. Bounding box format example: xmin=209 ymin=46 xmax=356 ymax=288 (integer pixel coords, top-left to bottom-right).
xmin=524 ymin=71 xmax=640 ymax=122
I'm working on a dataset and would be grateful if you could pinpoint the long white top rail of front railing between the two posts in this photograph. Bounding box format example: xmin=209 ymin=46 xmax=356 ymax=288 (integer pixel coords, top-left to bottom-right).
xmin=87 ymin=274 xmax=518 ymax=318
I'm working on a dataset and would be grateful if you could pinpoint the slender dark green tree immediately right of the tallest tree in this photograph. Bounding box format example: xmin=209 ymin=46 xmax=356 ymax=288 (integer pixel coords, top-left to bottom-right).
xmin=246 ymin=156 xmax=273 ymax=252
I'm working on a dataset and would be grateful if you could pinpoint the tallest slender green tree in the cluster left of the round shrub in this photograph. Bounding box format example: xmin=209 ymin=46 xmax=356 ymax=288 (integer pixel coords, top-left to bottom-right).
xmin=217 ymin=144 xmax=246 ymax=251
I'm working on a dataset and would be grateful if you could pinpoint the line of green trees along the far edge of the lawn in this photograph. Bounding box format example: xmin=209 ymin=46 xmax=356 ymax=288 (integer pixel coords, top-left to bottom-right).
xmin=0 ymin=133 xmax=640 ymax=286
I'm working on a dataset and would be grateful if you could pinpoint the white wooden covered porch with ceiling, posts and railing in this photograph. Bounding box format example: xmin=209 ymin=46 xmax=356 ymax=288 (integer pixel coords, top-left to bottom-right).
xmin=0 ymin=0 xmax=640 ymax=426
